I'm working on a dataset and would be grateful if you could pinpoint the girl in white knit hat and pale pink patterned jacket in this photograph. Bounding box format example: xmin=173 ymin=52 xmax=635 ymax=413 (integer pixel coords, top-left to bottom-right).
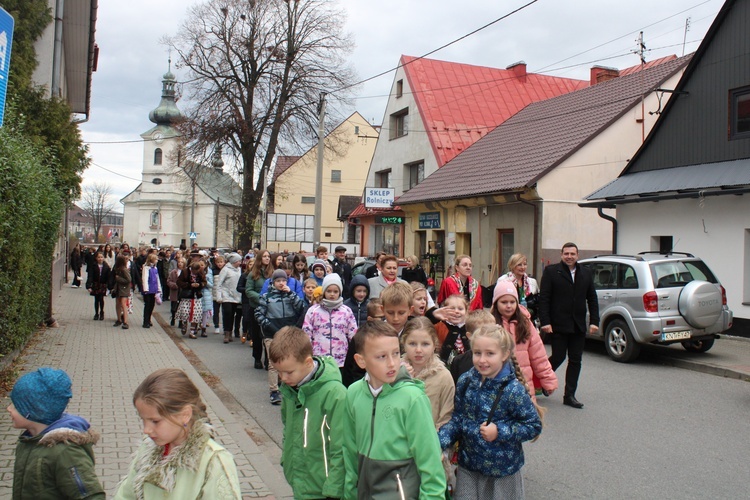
xmin=302 ymin=273 xmax=357 ymax=368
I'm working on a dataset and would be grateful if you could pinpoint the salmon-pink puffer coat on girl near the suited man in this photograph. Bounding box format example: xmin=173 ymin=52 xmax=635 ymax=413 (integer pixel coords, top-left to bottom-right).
xmin=502 ymin=306 xmax=557 ymax=399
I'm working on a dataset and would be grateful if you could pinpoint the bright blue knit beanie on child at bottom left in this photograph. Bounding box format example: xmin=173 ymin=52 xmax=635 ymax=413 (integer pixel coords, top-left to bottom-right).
xmin=10 ymin=368 xmax=73 ymax=425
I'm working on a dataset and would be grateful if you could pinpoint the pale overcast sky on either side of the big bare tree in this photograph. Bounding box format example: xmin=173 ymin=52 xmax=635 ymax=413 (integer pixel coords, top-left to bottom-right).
xmin=81 ymin=0 xmax=724 ymax=207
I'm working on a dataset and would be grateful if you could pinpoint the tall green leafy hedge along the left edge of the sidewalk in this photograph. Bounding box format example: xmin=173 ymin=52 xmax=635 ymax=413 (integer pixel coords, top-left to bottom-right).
xmin=0 ymin=114 xmax=63 ymax=357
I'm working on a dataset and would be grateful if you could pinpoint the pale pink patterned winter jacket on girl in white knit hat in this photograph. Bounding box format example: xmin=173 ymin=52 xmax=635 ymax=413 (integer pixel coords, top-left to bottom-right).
xmin=302 ymin=304 xmax=357 ymax=366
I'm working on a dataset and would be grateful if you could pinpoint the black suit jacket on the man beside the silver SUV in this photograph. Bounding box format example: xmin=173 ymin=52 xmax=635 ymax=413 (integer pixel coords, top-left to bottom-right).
xmin=539 ymin=262 xmax=599 ymax=333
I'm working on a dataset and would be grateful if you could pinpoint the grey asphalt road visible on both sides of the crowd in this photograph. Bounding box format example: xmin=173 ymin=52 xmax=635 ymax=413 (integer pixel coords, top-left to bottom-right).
xmin=154 ymin=306 xmax=750 ymax=499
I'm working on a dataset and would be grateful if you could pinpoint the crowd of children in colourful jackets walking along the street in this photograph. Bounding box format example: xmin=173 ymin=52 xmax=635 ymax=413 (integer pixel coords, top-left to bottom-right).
xmin=20 ymin=251 xmax=557 ymax=499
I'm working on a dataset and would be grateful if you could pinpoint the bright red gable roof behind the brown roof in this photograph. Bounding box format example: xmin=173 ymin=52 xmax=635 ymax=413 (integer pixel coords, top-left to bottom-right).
xmin=400 ymin=55 xmax=588 ymax=167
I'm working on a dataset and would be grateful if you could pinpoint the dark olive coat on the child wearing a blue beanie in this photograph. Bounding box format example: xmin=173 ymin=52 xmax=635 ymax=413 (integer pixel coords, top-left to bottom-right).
xmin=13 ymin=413 xmax=105 ymax=500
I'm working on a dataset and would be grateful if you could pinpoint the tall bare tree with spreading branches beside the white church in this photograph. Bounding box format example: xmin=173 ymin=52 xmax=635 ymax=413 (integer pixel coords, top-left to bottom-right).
xmin=165 ymin=0 xmax=354 ymax=247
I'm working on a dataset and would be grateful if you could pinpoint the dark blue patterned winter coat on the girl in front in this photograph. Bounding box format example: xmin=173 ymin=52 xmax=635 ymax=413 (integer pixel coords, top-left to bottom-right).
xmin=438 ymin=363 xmax=542 ymax=477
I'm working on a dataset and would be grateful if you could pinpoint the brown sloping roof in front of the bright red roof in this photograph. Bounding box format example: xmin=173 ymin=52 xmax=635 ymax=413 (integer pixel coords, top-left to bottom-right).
xmin=396 ymin=55 xmax=691 ymax=205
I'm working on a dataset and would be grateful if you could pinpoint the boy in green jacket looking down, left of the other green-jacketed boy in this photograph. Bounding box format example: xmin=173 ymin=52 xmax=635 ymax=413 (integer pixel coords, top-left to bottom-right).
xmin=268 ymin=326 xmax=346 ymax=499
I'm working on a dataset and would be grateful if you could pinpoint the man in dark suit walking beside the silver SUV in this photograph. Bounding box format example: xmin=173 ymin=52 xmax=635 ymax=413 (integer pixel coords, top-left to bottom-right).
xmin=539 ymin=243 xmax=599 ymax=408
